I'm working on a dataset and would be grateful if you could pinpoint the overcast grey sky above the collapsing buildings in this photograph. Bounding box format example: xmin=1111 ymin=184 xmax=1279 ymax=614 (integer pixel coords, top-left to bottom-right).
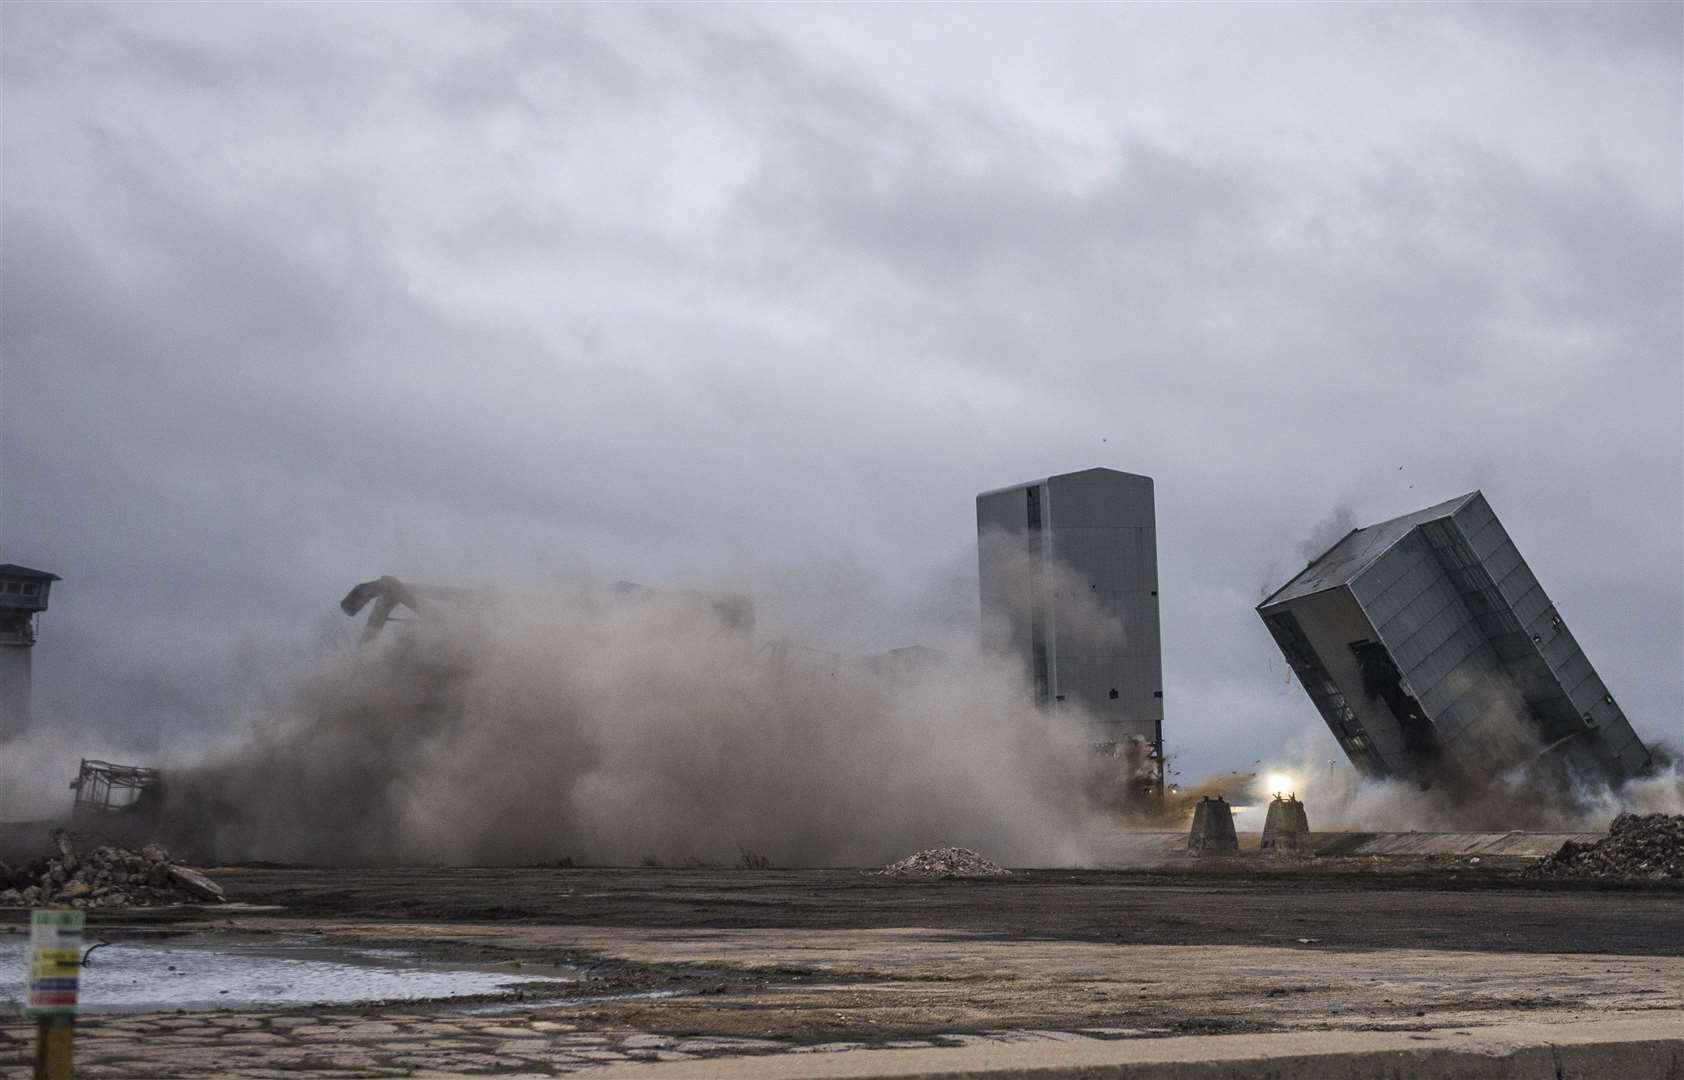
xmin=0 ymin=3 xmax=1684 ymax=773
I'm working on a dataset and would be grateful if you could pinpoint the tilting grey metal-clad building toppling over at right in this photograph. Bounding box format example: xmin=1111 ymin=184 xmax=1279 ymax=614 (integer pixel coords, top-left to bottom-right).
xmin=1258 ymin=492 xmax=1650 ymax=783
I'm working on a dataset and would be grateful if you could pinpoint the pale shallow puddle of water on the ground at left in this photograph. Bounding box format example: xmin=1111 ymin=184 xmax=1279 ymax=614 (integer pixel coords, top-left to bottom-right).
xmin=0 ymin=937 xmax=576 ymax=1013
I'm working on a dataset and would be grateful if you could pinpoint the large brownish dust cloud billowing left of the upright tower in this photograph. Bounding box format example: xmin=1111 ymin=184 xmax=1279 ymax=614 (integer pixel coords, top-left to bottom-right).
xmin=151 ymin=572 xmax=1115 ymax=866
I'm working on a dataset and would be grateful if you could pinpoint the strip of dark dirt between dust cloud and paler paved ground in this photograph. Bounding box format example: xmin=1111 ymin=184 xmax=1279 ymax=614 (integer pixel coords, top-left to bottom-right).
xmin=216 ymin=858 xmax=1684 ymax=955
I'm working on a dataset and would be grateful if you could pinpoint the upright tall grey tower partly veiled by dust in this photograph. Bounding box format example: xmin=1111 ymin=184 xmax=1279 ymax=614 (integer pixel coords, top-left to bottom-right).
xmin=977 ymin=468 xmax=1164 ymax=795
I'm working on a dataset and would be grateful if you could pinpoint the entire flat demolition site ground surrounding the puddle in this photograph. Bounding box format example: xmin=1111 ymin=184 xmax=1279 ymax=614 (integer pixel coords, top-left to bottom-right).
xmin=0 ymin=854 xmax=1684 ymax=1078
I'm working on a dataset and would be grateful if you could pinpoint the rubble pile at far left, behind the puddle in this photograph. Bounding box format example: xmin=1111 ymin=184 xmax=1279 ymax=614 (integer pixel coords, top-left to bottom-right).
xmin=0 ymin=832 xmax=226 ymax=908
